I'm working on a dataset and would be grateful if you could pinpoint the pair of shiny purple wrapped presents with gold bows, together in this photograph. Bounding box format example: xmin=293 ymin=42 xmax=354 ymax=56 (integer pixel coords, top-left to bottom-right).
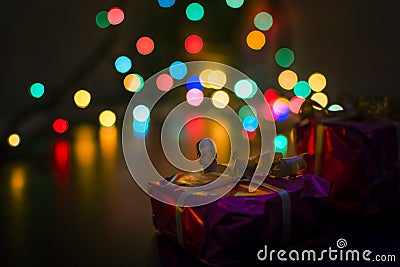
xmin=149 ymin=100 xmax=400 ymax=266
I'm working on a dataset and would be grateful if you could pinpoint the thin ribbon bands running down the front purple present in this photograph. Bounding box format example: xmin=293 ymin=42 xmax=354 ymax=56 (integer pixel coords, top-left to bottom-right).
xmin=175 ymin=176 xmax=291 ymax=248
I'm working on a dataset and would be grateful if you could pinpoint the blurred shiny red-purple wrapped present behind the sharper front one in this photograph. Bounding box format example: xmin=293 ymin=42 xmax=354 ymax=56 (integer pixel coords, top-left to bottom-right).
xmin=296 ymin=119 xmax=399 ymax=214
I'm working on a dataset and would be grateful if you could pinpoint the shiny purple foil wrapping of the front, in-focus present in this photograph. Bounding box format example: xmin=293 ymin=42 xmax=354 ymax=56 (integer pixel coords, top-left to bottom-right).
xmin=149 ymin=174 xmax=330 ymax=266
